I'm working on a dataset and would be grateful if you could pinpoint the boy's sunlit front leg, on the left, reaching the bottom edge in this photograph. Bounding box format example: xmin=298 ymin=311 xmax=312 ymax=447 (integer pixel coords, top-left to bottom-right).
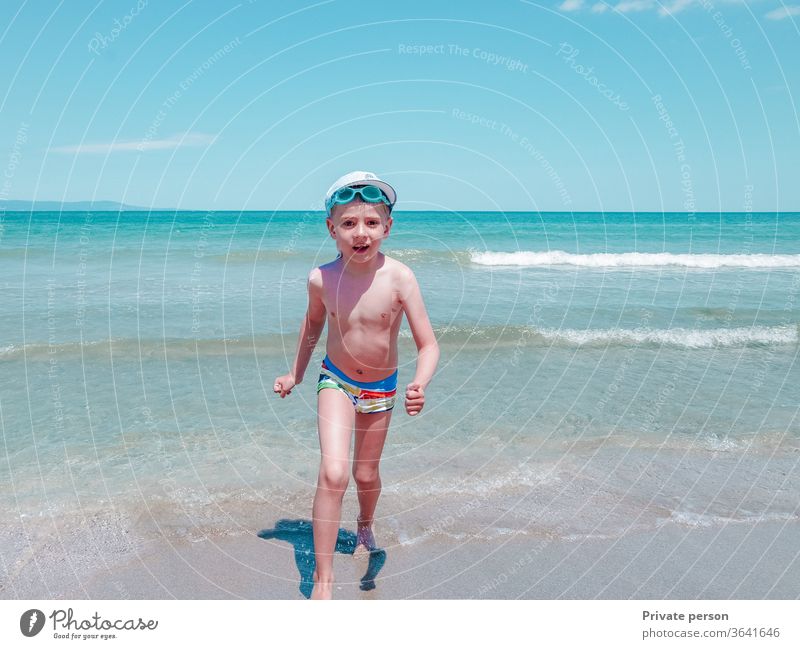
xmin=312 ymin=388 xmax=355 ymax=598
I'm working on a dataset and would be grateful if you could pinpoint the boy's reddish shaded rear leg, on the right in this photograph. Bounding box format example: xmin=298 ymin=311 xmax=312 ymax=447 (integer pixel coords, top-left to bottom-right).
xmin=353 ymin=410 xmax=392 ymax=550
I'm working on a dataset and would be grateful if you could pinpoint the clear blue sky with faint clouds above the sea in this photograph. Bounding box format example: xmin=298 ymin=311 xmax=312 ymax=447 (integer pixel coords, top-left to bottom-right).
xmin=0 ymin=0 xmax=800 ymax=212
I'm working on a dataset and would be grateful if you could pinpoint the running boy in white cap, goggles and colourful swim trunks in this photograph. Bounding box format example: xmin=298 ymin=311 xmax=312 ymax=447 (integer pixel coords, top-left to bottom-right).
xmin=274 ymin=171 xmax=439 ymax=599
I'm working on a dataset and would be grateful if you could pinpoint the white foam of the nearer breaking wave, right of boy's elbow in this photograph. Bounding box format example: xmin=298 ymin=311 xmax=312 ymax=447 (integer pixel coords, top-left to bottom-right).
xmin=539 ymin=324 xmax=798 ymax=349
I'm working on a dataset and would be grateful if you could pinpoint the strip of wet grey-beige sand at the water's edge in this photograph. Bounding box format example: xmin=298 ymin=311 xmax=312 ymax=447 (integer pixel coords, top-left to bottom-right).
xmin=0 ymin=504 xmax=800 ymax=599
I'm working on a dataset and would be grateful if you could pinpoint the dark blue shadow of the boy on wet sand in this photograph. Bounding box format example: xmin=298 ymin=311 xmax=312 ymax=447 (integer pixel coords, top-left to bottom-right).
xmin=258 ymin=518 xmax=386 ymax=599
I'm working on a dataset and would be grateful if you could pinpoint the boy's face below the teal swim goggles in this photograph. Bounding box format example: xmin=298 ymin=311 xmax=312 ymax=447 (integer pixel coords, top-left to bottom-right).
xmin=328 ymin=199 xmax=392 ymax=263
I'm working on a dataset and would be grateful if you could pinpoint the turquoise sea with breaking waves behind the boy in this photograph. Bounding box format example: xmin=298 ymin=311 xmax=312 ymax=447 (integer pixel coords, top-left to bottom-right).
xmin=0 ymin=212 xmax=800 ymax=543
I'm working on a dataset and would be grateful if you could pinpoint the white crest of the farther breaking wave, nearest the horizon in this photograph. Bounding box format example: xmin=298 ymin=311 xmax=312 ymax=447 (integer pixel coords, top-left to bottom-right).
xmin=470 ymin=250 xmax=800 ymax=268
